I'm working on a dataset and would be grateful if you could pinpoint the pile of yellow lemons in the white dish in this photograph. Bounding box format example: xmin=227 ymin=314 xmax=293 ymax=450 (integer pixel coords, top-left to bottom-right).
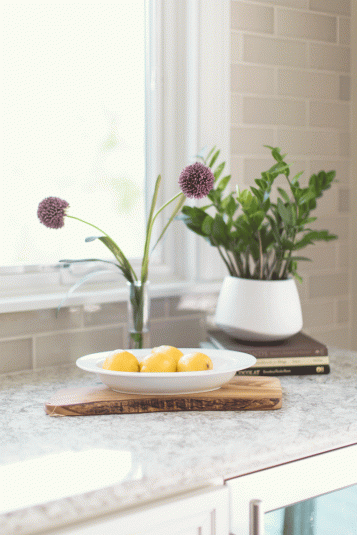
xmin=103 ymin=346 xmax=213 ymax=373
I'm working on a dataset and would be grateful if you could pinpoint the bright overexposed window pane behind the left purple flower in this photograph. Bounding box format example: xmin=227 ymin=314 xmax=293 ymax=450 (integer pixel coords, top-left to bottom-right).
xmin=0 ymin=0 xmax=145 ymax=266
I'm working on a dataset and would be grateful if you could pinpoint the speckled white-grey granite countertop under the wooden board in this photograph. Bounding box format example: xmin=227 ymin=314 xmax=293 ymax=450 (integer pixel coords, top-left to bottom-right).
xmin=0 ymin=349 xmax=357 ymax=535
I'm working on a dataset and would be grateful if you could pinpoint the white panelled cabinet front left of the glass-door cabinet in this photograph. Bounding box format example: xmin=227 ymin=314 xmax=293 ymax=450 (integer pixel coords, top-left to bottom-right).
xmin=49 ymin=485 xmax=229 ymax=535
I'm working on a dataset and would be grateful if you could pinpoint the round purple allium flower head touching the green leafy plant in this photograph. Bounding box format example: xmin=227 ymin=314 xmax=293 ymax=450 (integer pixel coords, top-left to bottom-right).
xmin=179 ymin=162 xmax=214 ymax=199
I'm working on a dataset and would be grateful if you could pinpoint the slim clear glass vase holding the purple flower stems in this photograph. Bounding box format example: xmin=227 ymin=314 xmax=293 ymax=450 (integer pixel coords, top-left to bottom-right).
xmin=127 ymin=281 xmax=150 ymax=349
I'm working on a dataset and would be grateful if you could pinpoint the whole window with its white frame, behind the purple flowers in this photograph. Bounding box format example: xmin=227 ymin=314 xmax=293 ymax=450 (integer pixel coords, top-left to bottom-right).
xmin=0 ymin=0 xmax=230 ymax=312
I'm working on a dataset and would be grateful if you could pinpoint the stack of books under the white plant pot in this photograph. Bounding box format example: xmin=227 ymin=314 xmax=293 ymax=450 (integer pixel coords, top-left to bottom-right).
xmin=208 ymin=330 xmax=330 ymax=376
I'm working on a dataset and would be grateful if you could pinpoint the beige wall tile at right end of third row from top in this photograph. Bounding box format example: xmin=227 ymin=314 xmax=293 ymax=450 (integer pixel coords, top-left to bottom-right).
xmin=309 ymin=43 xmax=350 ymax=72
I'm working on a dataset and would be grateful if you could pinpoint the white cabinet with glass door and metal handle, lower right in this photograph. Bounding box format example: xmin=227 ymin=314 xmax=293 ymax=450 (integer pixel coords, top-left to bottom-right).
xmin=226 ymin=445 xmax=357 ymax=535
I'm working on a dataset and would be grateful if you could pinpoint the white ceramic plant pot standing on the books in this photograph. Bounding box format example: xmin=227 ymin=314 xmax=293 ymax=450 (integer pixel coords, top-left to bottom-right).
xmin=215 ymin=277 xmax=302 ymax=342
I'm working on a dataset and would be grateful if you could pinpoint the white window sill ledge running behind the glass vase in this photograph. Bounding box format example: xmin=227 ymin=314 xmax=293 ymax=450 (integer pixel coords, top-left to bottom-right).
xmin=0 ymin=279 xmax=222 ymax=313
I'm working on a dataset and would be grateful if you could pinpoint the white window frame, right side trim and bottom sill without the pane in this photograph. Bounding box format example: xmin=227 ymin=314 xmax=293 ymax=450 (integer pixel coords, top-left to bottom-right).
xmin=0 ymin=0 xmax=230 ymax=313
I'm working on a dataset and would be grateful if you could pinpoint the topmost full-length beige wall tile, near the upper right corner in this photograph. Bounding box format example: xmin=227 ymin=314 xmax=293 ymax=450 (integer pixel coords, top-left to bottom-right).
xmin=276 ymin=9 xmax=337 ymax=43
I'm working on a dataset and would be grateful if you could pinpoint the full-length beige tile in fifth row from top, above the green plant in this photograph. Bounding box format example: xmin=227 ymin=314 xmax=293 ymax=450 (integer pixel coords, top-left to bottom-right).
xmin=243 ymin=97 xmax=306 ymax=126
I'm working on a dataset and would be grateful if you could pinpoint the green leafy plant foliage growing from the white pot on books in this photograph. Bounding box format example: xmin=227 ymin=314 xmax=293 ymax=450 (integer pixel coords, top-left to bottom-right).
xmin=177 ymin=145 xmax=337 ymax=281
